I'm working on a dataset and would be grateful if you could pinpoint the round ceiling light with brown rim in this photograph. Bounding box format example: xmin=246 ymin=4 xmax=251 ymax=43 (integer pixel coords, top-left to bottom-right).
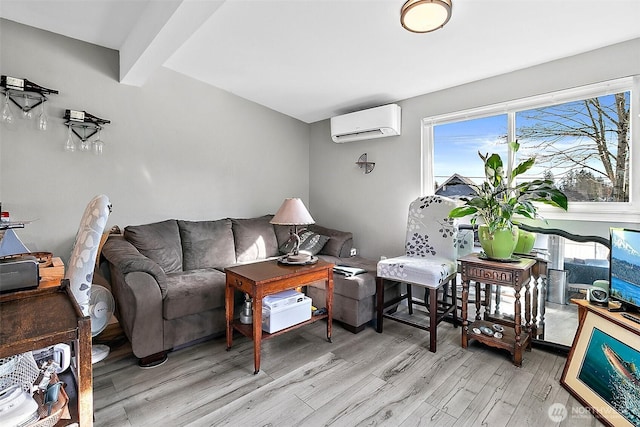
xmin=400 ymin=0 xmax=452 ymax=33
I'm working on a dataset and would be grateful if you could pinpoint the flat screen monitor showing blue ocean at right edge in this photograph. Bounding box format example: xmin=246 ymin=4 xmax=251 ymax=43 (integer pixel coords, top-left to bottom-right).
xmin=609 ymin=228 xmax=640 ymax=311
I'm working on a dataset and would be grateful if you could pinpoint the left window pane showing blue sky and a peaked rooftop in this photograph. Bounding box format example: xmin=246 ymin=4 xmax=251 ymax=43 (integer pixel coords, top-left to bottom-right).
xmin=433 ymin=114 xmax=508 ymax=196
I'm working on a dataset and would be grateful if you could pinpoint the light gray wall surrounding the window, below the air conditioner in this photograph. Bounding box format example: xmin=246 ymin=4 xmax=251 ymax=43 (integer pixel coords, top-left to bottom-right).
xmin=309 ymin=39 xmax=640 ymax=259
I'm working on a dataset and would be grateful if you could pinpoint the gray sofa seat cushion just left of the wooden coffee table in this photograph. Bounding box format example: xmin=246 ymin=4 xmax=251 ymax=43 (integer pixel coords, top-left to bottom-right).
xmin=162 ymin=268 xmax=226 ymax=320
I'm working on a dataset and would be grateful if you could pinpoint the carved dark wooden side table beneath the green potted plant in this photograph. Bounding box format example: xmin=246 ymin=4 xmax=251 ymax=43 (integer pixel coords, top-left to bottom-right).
xmin=460 ymin=253 xmax=536 ymax=366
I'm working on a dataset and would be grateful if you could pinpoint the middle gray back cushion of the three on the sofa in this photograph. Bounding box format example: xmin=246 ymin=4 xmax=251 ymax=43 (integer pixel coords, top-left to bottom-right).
xmin=178 ymin=219 xmax=236 ymax=271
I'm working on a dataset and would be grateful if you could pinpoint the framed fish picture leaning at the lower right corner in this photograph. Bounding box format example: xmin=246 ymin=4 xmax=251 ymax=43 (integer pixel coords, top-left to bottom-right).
xmin=560 ymin=311 xmax=640 ymax=427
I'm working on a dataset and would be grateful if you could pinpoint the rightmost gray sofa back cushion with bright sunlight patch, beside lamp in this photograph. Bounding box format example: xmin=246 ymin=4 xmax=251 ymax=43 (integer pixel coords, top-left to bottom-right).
xmin=231 ymin=215 xmax=278 ymax=262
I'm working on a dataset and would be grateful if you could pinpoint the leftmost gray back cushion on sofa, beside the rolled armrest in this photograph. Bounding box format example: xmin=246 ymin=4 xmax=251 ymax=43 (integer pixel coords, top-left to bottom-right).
xmin=124 ymin=219 xmax=182 ymax=273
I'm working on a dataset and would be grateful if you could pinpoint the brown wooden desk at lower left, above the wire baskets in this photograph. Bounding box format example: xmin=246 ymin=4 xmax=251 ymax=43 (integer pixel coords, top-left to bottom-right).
xmin=0 ymin=281 xmax=93 ymax=427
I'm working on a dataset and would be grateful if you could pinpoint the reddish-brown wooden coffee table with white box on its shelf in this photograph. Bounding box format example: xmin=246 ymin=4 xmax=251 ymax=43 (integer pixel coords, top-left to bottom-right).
xmin=225 ymin=260 xmax=333 ymax=374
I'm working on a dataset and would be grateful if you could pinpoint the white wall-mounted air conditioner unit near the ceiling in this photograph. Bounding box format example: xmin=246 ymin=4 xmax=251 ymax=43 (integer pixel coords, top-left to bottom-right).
xmin=331 ymin=104 xmax=401 ymax=142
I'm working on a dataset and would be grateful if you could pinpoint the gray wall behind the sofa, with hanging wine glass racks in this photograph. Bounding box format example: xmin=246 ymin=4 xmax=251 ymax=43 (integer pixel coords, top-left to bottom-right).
xmin=0 ymin=20 xmax=309 ymax=260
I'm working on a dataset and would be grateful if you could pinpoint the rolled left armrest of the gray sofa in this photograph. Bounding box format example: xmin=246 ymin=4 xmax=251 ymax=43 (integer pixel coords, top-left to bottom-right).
xmin=102 ymin=236 xmax=167 ymax=299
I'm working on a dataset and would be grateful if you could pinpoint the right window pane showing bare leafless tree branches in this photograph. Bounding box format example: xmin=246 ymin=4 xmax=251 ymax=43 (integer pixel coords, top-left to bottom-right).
xmin=516 ymin=92 xmax=631 ymax=202
